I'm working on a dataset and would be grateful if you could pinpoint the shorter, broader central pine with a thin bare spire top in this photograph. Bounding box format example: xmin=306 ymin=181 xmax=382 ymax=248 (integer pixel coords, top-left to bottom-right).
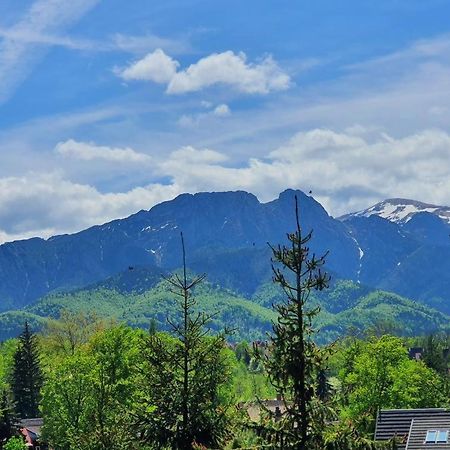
xmin=138 ymin=234 xmax=230 ymax=450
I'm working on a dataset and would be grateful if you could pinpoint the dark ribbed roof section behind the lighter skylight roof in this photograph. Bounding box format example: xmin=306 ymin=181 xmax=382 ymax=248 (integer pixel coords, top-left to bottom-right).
xmin=375 ymin=408 xmax=450 ymax=450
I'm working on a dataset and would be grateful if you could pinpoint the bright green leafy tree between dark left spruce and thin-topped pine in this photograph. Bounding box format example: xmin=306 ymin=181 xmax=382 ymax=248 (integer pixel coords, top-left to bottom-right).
xmin=42 ymin=326 xmax=142 ymax=450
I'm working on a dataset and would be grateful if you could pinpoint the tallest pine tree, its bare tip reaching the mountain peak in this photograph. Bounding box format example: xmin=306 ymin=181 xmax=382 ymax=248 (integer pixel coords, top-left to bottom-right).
xmin=265 ymin=197 xmax=329 ymax=450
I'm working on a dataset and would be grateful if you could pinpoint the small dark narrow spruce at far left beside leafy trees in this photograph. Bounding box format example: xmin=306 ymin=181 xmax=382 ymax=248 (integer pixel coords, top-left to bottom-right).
xmin=11 ymin=322 xmax=42 ymax=418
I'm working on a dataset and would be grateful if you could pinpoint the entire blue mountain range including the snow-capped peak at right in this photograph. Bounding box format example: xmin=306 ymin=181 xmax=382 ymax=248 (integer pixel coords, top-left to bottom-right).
xmin=0 ymin=190 xmax=450 ymax=342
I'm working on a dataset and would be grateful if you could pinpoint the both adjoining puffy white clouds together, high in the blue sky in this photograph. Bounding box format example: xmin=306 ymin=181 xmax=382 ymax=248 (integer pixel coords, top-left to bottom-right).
xmin=115 ymin=49 xmax=291 ymax=94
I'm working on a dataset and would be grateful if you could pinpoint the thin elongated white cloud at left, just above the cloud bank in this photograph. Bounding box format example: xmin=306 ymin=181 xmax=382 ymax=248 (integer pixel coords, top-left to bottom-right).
xmin=55 ymin=139 xmax=151 ymax=163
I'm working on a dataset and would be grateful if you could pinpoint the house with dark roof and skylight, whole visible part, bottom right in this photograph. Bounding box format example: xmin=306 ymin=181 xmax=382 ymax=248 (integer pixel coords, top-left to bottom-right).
xmin=375 ymin=408 xmax=450 ymax=450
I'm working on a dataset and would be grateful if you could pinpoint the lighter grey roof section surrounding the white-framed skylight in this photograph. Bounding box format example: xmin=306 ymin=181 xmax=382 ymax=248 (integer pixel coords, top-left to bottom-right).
xmin=406 ymin=415 xmax=450 ymax=450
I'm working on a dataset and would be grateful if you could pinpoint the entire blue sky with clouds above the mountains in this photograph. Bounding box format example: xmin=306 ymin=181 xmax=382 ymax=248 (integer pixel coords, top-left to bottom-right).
xmin=0 ymin=0 xmax=450 ymax=243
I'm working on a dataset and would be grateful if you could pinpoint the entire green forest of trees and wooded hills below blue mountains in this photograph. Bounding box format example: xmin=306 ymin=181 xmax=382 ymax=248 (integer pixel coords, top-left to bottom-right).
xmin=0 ymin=205 xmax=450 ymax=450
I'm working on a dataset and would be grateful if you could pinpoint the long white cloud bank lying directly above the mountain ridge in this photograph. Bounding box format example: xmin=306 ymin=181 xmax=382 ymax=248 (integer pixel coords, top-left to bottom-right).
xmin=0 ymin=126 xmax=450 ymax=240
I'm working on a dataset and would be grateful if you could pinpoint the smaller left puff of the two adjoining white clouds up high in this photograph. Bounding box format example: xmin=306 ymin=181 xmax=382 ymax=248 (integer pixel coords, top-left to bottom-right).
xmin=115 ymin=49 xmax=179 ymax=83
